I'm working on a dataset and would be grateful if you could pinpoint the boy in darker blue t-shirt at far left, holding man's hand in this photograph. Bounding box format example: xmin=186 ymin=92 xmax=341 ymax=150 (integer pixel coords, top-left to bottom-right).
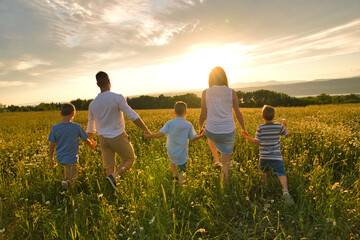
xmin=48 ymin=103 xmax=97 ymax=188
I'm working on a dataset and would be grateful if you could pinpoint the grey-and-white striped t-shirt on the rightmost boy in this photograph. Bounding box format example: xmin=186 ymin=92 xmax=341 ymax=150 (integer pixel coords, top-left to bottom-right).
xmin=255 ymin=123 xmax=288 ymax=161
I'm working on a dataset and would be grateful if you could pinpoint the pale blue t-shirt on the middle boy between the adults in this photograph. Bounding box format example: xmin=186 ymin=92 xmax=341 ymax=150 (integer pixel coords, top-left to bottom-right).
xmin=160 ymin=117 xmax=197 ymax=165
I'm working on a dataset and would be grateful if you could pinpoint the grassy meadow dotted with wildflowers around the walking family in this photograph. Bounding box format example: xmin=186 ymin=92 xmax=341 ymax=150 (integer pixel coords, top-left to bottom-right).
xmin=0 ymin=104 xmax=360 ymax=239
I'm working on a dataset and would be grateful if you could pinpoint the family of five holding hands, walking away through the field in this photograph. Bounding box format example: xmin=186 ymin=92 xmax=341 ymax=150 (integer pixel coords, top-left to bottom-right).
xmin=48 ymin=67 xmax=293 ymax=205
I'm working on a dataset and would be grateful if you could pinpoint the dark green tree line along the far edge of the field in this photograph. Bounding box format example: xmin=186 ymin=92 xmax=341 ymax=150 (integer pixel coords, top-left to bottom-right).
xmin=0 ymin=90 xmax=360 ymax=112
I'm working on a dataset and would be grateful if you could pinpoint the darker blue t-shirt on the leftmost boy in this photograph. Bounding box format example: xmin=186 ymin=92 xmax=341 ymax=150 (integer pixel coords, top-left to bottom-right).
xmin=48 ymin=122 xmax=89 ymax=164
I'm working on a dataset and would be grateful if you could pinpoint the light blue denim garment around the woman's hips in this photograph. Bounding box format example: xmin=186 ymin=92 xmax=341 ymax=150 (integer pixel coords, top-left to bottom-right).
xmin=205 ymin=129 xmax=235 ymax=154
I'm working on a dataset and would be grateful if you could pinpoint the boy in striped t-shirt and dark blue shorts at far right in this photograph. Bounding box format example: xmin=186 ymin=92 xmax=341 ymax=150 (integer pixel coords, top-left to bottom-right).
xmin=242 ymin=105 xmax=294 ymax=205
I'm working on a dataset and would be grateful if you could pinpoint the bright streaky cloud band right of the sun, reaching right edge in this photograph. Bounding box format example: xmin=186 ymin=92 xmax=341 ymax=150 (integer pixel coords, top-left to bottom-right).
xmin=239 ymin=18 xmax=360 ymax=67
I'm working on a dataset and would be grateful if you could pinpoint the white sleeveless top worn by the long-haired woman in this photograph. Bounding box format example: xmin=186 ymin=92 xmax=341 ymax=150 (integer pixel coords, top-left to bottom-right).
xmin=205 ymin=85 xmax=235 ymax=134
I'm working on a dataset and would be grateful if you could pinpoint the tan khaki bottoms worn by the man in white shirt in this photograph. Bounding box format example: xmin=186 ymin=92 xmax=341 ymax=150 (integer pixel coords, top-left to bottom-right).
xmin=99 ymin=132 xmax=135 ymax=169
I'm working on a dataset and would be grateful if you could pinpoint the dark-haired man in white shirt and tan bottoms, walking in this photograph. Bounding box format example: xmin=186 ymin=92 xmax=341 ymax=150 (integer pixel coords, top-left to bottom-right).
xmin=87 ymin=71 xmax=150 ymax=190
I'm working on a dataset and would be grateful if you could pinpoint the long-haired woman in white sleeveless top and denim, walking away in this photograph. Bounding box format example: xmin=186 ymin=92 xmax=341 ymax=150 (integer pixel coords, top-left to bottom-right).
xmin=199 ymin=67 xmax=248 ymax=179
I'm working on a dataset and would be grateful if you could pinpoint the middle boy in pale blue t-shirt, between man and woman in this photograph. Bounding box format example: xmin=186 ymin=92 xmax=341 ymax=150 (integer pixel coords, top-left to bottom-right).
xmin=145 ymin=101 xmax=204 ymax=186
